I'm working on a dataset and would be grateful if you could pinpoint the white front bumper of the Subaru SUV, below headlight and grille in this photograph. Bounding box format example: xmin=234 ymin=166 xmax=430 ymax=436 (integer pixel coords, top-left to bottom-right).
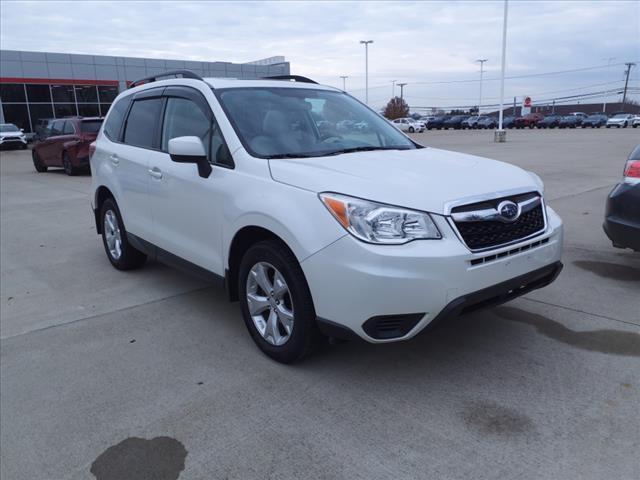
xmin=301 ymin=207 xmax=563 ymax=343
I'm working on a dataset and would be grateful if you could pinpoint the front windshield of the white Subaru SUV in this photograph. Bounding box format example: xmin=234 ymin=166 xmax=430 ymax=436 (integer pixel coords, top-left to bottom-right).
xmin=216 ymin=87 xmax=416 ymax=158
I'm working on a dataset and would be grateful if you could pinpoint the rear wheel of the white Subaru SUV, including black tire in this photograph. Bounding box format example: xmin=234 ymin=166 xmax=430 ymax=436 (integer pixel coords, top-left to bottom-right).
xmin=100 ymin=198 xmax=147 ymax=270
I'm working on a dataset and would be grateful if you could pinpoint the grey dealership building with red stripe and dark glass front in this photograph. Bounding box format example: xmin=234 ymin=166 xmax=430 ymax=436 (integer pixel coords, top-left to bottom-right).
xmin=0 ymin=50 xmax=290 ymax=132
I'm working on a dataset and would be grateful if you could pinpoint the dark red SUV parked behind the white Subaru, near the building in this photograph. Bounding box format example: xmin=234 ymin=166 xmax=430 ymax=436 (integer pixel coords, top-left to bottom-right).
xmin=32 ymin=117 xmax=102 ymax=175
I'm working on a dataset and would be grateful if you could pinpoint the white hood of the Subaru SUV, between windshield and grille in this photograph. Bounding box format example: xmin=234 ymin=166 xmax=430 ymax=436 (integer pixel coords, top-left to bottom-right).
xmin=269 ymin=148 xmax=539 ymax=214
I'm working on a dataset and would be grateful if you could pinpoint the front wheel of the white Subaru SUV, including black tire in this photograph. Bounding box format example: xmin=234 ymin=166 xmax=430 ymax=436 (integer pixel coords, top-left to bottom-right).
xmin=238 ymin=240 xmax=321 ymax=363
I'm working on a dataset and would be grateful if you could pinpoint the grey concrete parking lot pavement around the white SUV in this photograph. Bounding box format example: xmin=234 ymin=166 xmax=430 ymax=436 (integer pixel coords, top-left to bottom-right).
xmin=0 ymin=128 xmax=640 ymax=480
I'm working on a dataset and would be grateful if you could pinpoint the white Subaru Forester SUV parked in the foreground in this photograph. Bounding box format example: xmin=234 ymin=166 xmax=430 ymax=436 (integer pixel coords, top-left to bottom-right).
xmin=91 ymin=72 xmax=563 ymax=362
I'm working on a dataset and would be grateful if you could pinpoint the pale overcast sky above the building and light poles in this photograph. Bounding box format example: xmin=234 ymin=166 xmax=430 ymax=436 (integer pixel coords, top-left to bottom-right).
xmin=0 ymin=0 xmax=640 ymax=107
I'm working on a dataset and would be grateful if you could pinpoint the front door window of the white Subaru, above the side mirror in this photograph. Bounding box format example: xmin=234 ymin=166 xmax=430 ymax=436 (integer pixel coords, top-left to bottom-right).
xmin=162 ymin=97 xmax=213 ymax=159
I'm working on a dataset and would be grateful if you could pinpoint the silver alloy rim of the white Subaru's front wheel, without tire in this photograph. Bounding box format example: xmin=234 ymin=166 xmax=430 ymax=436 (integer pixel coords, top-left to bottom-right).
xmin=246 ymin=262 xmax=294 ymax=346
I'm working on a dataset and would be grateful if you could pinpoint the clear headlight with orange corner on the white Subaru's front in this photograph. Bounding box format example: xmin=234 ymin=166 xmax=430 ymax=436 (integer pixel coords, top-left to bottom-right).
xmin=320 ymin=193 xmax=442 ymax=245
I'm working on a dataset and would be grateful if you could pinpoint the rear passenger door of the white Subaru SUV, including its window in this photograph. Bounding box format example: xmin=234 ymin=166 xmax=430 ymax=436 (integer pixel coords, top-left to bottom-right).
xmin=114 ymin=88 xmax=164 ymax=241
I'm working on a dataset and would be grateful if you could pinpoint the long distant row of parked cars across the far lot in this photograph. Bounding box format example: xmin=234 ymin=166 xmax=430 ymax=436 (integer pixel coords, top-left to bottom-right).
xmin=404 ymin=112 xmax=640 ymax=129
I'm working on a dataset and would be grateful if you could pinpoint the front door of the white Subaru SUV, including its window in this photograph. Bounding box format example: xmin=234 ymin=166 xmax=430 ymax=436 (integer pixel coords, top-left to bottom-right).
xmin=149 ymin=91 xmax=228 ymax=275
